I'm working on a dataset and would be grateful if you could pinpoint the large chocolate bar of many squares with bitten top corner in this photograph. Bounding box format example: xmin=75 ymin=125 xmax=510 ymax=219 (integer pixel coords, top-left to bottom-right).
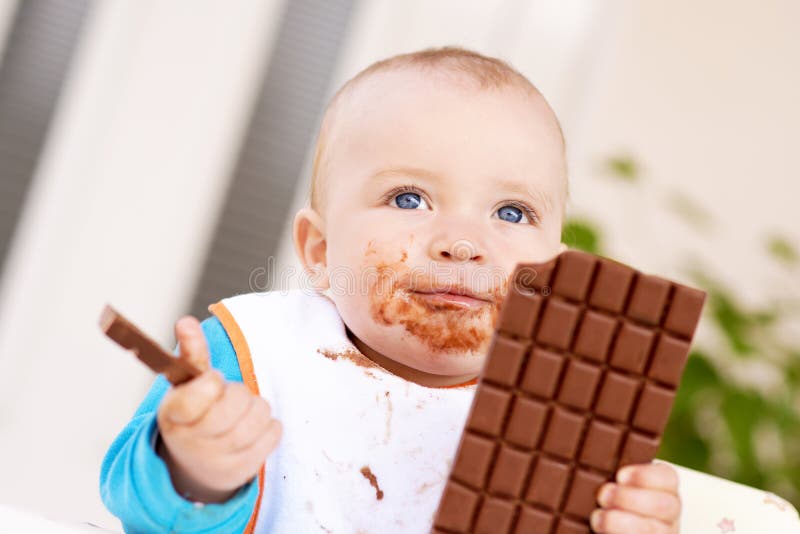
xmin=433 ymin=251 xmax=705 ymax=534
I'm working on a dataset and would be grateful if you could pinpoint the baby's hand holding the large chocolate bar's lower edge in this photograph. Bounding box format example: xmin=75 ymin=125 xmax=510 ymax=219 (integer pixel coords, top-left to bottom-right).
xmin=591 ymin=463 xmax=681 ymax=534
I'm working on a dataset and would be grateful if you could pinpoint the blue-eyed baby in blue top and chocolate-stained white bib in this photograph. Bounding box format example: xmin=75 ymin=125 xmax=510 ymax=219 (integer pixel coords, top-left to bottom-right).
xmin=101 ymin=48 xmax=681 ymax=534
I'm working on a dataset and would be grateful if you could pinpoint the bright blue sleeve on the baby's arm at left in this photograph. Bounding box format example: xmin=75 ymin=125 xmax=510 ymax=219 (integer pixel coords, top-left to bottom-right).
xmin=100 ymin=317 xmax=258 ymax=533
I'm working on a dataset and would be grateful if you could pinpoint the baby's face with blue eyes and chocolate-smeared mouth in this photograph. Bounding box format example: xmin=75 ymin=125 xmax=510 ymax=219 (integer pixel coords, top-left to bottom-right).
xmin=304 ymin=71 xmax=566 ymax=382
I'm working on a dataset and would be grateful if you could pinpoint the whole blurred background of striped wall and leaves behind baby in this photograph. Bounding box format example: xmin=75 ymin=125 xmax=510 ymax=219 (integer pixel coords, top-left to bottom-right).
xmin=0 ymin=0 xmax=800 ymax=528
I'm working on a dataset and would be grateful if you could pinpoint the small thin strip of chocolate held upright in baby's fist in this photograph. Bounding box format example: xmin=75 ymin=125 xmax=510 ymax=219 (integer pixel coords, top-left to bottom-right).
xmin=100 ymin=305 xmax=202 ymax=386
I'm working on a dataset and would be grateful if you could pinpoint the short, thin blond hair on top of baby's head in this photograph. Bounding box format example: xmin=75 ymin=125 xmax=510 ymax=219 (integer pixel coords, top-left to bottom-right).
xmin=310 ymin=46 xmax=565 ymax=212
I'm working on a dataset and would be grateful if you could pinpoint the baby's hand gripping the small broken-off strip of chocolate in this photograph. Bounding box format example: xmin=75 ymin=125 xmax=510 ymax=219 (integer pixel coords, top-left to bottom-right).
xmin=158 ymin=317 xmax=281 ymax=503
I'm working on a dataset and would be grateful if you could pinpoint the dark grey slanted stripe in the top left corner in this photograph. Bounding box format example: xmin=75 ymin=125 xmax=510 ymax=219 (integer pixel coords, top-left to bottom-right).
xmin=0 ymin=0 xmax=91 ymax=276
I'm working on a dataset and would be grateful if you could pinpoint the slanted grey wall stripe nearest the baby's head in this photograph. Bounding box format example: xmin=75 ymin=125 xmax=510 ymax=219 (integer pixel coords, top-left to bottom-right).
xmin=190 ymin=0 xmax=354 ymax=318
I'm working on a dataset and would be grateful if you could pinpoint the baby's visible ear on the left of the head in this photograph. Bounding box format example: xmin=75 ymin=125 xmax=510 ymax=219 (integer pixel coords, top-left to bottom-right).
xmin=292 ymin=208 xmax=330 ymax=291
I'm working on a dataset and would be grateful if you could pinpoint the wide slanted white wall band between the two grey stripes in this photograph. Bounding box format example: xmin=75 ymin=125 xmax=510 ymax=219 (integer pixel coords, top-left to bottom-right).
xmin=0 ymin=0 xmax=282 ymax=525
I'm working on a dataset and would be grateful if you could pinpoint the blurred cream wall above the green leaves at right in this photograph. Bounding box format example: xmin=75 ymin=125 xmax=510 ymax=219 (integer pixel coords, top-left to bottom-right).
xmin=572 ymin=0 xmax=800 ymax=302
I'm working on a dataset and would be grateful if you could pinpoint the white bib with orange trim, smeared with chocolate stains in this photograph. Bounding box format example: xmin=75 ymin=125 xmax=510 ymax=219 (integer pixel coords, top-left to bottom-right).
xmin=211 ymin=290 xmax=475 ymax=534
